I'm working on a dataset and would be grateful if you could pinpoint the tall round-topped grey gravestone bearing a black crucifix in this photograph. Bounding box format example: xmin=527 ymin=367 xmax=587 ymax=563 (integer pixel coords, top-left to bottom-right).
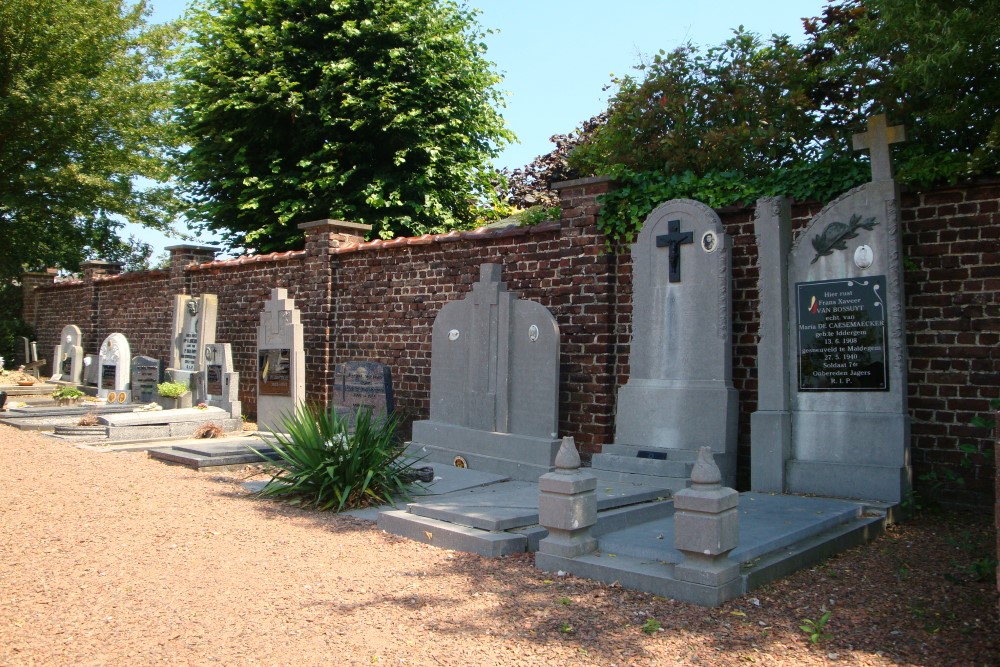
xmin=593 ymin=199 xmax=738 ymax=488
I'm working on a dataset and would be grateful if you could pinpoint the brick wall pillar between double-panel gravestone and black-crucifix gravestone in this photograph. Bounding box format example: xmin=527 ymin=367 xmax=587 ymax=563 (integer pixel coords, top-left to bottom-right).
xmin=542 ymin=176 xmax=618 ymax=454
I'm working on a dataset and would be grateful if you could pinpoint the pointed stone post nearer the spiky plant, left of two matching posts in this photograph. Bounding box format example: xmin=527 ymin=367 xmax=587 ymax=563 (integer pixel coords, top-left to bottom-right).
xmin=538 ymin=436 xmax=597 ymax=558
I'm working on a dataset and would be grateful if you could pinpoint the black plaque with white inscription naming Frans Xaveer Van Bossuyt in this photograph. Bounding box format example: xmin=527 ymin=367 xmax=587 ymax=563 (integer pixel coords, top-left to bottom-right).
xmin=795 ymin=276 xmax=889 ymax=391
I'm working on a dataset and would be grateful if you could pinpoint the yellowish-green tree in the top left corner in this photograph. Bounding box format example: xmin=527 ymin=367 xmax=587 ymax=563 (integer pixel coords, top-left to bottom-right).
xmin=0 ymin=0 xmax=177 ymax=281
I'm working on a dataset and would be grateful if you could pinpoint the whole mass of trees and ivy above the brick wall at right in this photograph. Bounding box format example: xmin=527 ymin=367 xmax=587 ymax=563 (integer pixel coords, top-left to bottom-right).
xmin=504 ymin=0 xmax=1000 ymax=239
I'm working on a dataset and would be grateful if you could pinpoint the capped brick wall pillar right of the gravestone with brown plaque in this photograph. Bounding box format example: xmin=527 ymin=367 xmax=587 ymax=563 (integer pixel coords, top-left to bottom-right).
xmin=295 ymin=219 xmax=371 ymax=405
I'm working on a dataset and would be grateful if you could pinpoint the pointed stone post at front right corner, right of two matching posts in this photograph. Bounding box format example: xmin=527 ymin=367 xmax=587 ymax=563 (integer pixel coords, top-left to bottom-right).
xmin=674 ymin=447 xmax=740 ymax=587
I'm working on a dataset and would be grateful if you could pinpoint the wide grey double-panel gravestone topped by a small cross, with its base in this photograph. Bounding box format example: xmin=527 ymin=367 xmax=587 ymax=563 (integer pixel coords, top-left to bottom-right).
xmin=411 ymin=264 xmax=560 ymax=481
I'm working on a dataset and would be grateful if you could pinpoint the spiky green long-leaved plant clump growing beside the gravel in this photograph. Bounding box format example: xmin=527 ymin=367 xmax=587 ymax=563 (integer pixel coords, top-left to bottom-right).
xmin=255 ymin=405 xmax=415 ymax=512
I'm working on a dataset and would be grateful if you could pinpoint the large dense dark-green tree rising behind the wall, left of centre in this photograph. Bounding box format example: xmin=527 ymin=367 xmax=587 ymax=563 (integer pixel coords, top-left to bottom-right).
xmin=179 ymin=0 xmax=512 ymax=252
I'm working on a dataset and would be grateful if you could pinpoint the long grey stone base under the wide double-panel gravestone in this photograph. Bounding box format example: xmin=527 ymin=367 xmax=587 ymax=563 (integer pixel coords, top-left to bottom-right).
xmin=408 ymin=420 xmax=561 ymax=482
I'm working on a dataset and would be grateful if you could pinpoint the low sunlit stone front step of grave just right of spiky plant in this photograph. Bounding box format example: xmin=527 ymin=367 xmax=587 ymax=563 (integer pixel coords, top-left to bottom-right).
xmin=377 ymin=510 xmax=528 ymax=558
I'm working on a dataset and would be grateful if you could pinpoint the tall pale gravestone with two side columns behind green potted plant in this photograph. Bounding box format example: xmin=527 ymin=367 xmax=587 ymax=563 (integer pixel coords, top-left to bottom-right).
xmin=167 ymin=294 xmax=218 ymax=402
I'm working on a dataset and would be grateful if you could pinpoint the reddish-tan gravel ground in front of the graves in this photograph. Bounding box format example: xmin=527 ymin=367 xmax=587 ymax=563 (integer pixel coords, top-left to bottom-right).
xmin=0 ymin=426 xmax=1000 ymax=667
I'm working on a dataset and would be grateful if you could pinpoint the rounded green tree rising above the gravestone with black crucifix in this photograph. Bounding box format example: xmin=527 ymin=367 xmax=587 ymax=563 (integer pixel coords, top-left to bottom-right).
xmin=570 ymin=28 xmax=825 ymax=176
